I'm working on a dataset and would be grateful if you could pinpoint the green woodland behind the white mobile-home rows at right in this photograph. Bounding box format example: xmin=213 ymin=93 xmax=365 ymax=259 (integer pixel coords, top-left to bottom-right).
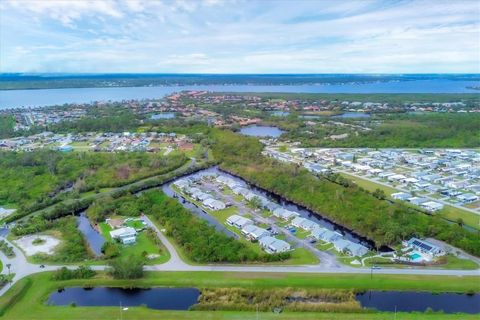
xmin=282 ymin=113 xmax=480 ymax=148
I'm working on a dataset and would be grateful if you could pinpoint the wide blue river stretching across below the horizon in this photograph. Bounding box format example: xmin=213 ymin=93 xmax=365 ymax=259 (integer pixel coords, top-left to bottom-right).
xmin=0 ymin=79 xmax=480 ymax=109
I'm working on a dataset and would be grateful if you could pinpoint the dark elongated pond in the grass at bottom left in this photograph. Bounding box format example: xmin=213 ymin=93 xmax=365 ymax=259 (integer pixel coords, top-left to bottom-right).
xmin=48 ymin=287 xmax=200 ymax=310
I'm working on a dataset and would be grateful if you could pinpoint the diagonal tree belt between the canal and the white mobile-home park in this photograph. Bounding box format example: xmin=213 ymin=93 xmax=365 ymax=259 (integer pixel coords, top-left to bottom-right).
xmin=213 ymin=132 xmax=480 ymax=256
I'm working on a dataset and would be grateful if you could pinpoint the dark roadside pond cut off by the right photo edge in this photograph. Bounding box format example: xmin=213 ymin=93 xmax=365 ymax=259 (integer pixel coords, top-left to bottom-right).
xmin=357 ymin=291 xmax=480 ymax=314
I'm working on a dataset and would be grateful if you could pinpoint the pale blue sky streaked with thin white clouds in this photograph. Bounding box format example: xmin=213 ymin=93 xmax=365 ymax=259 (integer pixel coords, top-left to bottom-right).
xmin=0 ymin=0 xmax=480 ymax=73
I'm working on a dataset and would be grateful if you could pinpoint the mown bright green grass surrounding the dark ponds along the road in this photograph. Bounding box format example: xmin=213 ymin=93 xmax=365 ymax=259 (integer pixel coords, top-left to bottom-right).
xmin=0 ymin=272 xmax=480 ymax=320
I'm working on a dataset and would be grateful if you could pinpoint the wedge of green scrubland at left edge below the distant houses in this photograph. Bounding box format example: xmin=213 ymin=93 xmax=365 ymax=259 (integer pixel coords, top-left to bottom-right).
xmin=0 ymin=150 xmax=187 ymax=221
